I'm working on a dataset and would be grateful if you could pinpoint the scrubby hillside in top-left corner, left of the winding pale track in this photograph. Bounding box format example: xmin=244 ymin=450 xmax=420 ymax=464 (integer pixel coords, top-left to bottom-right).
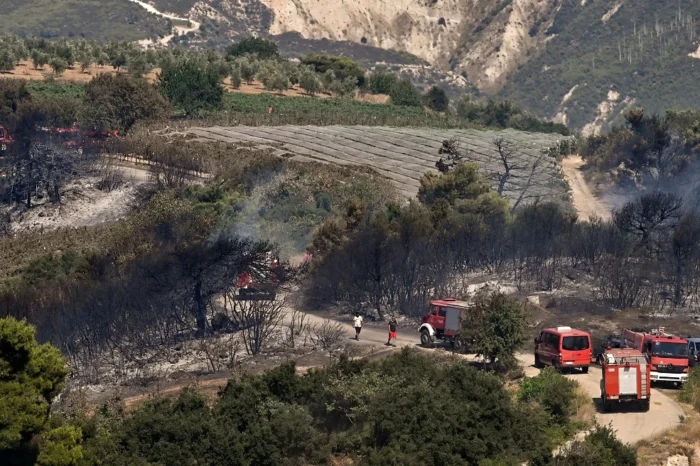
xmin=0 ymin=0 xmax=170 ymax=41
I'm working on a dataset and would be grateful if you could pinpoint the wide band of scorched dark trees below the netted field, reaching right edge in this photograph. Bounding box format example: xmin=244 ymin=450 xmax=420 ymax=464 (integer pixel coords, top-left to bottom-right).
xmin=307 ymin=155 xmax=700 ymax=316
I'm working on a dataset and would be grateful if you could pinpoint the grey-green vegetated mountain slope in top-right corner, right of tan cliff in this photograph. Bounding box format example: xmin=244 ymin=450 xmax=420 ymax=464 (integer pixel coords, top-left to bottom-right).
xmin=499 ymin=0 xmax=700 ymax=128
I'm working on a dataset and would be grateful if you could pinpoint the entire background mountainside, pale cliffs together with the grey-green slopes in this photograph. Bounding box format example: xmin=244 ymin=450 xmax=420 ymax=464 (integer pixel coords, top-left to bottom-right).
xmin=9 ymin=0 xmax=700 ymax=129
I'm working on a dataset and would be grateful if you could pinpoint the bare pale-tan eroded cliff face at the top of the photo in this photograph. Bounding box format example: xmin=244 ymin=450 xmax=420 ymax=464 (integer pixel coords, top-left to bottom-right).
xmin=261 ymin=0 xmax=560 ymax=92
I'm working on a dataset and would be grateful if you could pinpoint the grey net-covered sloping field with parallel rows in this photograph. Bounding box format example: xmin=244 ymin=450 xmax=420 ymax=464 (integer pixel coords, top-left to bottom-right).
xmin=189 ymin=125 xmax=568 ymax=204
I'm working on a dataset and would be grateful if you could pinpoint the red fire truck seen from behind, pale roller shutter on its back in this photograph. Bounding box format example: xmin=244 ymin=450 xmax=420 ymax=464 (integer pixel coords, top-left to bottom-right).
xmin=600 ymin=348 xmax=651 ymax=411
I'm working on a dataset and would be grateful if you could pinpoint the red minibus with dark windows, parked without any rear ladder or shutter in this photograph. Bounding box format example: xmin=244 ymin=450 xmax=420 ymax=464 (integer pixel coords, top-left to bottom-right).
xmin=535 ymin=327 xmax=593 ymax=374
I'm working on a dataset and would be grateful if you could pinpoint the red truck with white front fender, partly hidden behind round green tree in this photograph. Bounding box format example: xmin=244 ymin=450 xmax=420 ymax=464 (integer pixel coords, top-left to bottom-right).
xmin=418 ymin=298 xmax=469 ymax=351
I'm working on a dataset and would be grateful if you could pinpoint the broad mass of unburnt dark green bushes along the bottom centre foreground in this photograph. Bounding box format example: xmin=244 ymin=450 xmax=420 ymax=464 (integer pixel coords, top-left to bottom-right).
xmin=74 ymin=350 xmax=550 ymax=465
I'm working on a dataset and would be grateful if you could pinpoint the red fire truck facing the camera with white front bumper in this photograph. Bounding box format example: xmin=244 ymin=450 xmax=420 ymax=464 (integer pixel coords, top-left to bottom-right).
xmin=624 ymin=327 xmax=688 ymax=385
